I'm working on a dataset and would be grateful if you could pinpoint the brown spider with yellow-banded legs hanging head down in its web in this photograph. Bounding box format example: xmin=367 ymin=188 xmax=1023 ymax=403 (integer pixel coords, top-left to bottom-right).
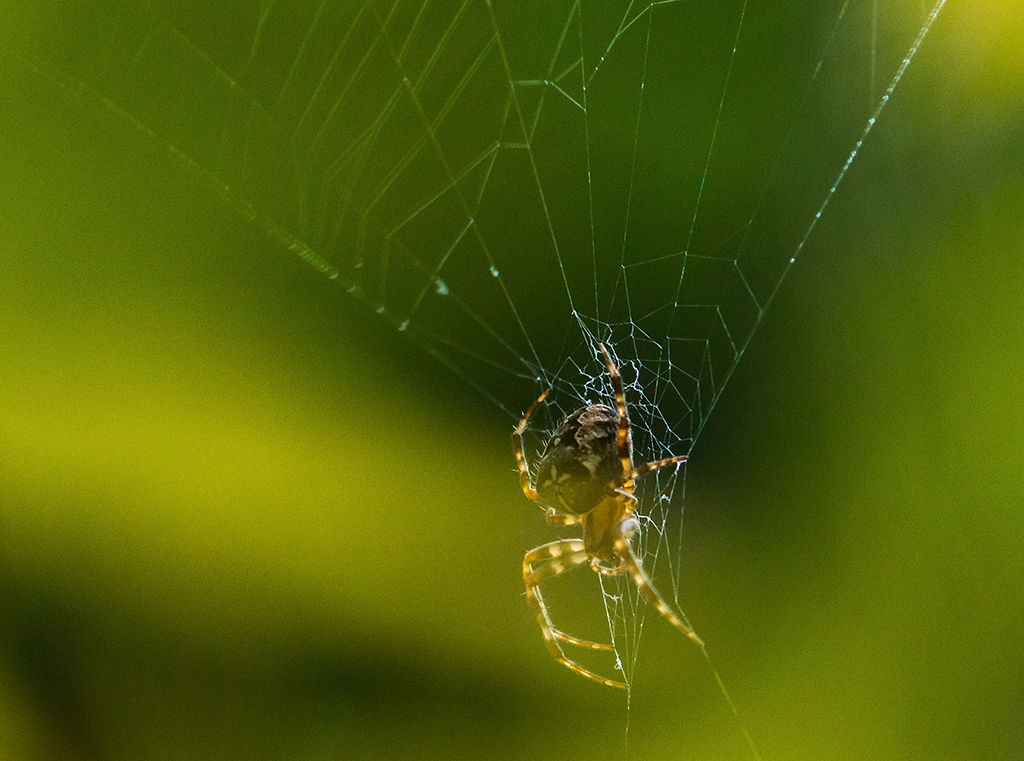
xmin=512 ymin=344 xmax=703 ymax=688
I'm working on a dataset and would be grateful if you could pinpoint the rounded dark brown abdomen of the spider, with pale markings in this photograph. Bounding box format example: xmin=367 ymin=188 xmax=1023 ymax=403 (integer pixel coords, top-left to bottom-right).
xmin=537 ymin=405 xmax=629 ymax=515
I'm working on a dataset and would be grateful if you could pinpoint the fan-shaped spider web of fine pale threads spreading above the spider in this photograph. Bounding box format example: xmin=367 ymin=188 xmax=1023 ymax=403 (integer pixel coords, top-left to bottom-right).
xmin=8 ymin=0 xmax=943 ymax=745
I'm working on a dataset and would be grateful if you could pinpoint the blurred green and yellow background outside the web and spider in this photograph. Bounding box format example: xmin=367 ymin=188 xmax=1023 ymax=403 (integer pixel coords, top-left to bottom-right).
xmin=0 ymin=2 xmax=1024 ymax=759
